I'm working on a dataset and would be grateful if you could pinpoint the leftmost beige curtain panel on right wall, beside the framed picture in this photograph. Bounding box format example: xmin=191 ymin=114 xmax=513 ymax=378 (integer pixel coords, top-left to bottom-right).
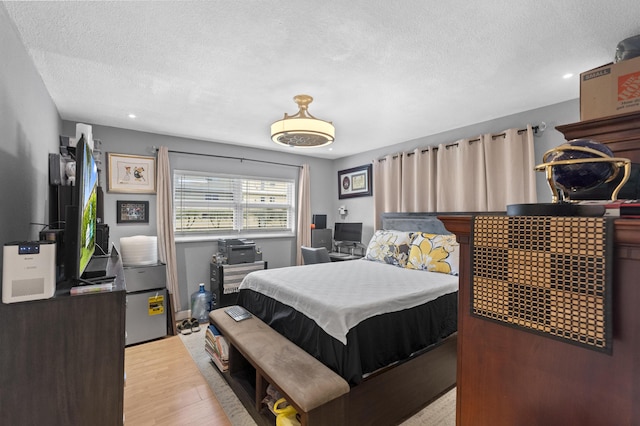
xmin=373 ymin=154 xmax=402 ymax=229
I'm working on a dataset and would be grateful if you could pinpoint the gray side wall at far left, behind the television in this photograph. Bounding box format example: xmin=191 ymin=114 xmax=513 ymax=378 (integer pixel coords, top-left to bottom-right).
xmin=0 ymin=4 xmax=61 ymax=272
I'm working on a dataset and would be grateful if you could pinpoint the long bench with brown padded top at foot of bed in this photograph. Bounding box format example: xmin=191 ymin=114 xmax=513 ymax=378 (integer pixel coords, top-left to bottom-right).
xmin=209 ymin=308 xmax=350 ymax=426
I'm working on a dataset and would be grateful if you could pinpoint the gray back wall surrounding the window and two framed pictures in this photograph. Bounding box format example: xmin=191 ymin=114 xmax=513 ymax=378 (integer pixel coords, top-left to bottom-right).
xmin=62 ymin=121 xmax=333 ymax=310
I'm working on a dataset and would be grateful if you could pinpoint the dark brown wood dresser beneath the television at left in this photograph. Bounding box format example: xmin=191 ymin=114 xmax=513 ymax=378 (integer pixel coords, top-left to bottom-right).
xmin=0 ymin=266 xmax=126 ymax=425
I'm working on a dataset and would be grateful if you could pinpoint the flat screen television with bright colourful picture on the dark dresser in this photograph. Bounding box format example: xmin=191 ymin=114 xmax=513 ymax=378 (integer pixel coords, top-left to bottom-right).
xmin=64 ymin=136 xmax=98 ymax=283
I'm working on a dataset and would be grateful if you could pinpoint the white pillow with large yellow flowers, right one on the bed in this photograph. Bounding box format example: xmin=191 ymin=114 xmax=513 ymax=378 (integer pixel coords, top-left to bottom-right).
xmin=407 ymin=232 xmax=459 ymax=275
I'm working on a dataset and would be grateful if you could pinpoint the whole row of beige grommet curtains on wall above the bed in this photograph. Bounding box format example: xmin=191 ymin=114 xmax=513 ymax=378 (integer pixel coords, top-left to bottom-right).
xmin=373 ymin=125 xmax=536 ymax=221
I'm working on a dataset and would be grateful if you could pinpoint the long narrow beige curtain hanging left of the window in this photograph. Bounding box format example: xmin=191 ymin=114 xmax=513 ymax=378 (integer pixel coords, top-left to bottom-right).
xmin=156 ymin=146 xmax=181 ymax=312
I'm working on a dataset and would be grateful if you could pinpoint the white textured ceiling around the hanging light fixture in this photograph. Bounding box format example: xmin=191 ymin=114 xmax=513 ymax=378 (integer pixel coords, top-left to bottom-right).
xmin=3 ymin=0 xmax=640 ymax=158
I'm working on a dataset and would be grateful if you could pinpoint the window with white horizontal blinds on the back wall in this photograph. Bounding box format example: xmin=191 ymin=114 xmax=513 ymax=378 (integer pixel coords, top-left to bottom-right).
xmin=173 ymin=170 xmax=295 ymax=234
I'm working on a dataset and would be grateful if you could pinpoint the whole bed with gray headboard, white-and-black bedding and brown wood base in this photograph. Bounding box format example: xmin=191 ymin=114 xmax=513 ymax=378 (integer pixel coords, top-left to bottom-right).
xmin=230 ymin=213 xmax=458 ymax=424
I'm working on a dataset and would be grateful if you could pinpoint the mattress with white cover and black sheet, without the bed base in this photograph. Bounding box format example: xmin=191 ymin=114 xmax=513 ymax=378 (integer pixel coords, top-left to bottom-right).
xmin=238 ymin=259 xmax=458 ymax=385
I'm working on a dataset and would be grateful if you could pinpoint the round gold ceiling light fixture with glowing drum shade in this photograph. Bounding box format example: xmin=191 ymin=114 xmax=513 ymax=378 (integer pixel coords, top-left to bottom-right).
xmin=271 ymin=95 xmax=336 ymax=148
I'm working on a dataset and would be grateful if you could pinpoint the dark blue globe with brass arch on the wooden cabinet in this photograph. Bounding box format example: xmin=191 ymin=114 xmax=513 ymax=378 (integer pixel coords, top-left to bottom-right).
xmin=544 ymin=139 xmax=618 ymax=194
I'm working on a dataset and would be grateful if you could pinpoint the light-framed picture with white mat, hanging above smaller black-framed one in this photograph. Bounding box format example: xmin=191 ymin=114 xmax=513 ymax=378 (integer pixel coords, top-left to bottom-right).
xmin=107 ymin=152 xmax=156 ymax=194
